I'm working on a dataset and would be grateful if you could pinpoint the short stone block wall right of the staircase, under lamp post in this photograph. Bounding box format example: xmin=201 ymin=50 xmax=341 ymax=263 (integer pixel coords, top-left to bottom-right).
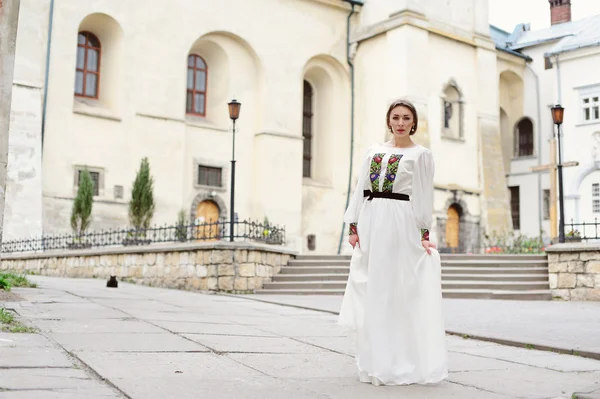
xmin=546 ymin=243 xmax=600 ymax=301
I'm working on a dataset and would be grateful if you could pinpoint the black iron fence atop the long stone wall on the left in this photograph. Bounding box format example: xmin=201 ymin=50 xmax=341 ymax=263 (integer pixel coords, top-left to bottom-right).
xmin=2 ymin=220 xmax=285 ymax=253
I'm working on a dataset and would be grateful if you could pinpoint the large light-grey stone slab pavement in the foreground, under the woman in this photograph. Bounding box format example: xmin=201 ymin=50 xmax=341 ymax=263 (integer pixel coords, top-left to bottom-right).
xmin=0 ymin=277 xmax=600 ymax=399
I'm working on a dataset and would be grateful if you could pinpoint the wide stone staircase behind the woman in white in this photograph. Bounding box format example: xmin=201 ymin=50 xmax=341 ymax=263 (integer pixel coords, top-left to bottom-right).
xmin=256 ymin=254 xmax=552 ymax=300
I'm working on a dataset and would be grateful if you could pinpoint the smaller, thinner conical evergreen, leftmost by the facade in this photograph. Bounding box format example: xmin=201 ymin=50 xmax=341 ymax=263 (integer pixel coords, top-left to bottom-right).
xmin=67 ymin=168 xmax=94 ymax=249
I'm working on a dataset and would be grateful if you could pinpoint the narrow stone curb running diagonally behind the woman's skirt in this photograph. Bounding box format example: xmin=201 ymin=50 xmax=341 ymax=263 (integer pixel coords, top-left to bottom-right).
xmin=224 ymin=293 xmax=600 ymax=362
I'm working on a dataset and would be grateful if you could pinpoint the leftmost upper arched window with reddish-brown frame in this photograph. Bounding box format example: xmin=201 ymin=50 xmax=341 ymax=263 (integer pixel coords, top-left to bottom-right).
xmin=75 ymin=31 xmax=101 ymax=98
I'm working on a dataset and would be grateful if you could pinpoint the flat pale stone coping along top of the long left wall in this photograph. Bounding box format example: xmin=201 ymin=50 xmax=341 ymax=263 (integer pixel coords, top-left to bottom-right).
xmin=0 ymin=241 xmax=298 ymax=260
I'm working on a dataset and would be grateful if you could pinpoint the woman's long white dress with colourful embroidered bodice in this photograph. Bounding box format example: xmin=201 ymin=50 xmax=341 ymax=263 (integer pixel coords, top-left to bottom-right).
xmin=338 ymin=143 xmax=448 ymax=385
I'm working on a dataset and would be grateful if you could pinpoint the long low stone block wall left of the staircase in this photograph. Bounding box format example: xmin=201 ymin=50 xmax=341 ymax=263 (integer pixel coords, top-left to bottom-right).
xmin=0 ymin=242 xmax=295 ymax=293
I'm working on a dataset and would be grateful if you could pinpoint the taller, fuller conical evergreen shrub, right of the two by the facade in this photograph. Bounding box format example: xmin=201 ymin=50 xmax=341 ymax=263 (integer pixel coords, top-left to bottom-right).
xmin=123 ymin=157 xmax=155 ymax=245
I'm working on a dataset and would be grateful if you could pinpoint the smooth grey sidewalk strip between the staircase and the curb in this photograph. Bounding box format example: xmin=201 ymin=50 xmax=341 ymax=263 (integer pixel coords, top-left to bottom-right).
xmin=233 ymin=295 xmax=600 ymax=360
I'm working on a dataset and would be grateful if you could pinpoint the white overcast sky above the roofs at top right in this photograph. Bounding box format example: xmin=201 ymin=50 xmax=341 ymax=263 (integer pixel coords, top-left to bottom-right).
xmin=489 ymin=0 xmax=600 ymax=33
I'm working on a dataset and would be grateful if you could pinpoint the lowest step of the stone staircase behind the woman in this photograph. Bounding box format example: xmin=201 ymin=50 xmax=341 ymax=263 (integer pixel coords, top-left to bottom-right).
xmin=256 ymin=289 xmax=552 ymax=301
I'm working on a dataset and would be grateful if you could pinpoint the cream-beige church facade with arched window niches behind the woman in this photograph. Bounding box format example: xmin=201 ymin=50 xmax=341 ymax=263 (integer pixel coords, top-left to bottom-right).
xmin=6 ymin=0 xmax=516 ymax=253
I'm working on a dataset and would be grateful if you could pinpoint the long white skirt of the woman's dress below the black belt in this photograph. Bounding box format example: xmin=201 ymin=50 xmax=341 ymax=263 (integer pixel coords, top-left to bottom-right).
xmin=338 ymin=198 xmax=448 ymax=385
